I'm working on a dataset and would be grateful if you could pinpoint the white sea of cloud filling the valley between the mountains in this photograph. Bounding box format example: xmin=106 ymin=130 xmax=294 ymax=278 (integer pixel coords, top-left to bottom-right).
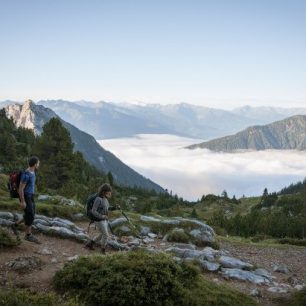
xmin=99 ymin=135 xmax=306 ymax=200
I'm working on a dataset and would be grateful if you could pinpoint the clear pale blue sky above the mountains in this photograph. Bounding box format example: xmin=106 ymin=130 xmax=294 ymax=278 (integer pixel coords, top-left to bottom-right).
xmin=0 ymin=0 xmax=306 ymax=108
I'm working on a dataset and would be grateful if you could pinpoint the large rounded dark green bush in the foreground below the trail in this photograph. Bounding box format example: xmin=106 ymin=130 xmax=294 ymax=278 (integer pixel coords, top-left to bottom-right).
xmin=53 ymin=251 xmax=256 ymax=306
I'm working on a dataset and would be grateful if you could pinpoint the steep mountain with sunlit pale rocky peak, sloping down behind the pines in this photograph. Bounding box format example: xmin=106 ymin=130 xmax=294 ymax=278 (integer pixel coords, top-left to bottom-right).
xmin=5 ymin=100 xmax=163 ymax=192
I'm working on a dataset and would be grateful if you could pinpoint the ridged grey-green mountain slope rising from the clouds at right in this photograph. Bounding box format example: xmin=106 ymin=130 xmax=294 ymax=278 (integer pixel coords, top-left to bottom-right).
xmin=187 ymin=115 xmax=306 ymax=152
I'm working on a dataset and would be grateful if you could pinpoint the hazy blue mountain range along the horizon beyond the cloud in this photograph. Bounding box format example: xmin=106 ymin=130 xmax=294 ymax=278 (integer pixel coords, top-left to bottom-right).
xmin=0 ymin=100 xmax=306 ymax=140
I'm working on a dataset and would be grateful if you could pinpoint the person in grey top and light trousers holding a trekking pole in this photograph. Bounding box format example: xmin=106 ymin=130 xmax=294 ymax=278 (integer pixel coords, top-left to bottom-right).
xmin=85 ymin=183 xmax=120 ymax=254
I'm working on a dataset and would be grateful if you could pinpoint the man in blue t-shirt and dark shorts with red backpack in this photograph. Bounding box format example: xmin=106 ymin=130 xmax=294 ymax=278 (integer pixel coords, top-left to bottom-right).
xmin=12 ymin=156 xmax=40 ymax=244
